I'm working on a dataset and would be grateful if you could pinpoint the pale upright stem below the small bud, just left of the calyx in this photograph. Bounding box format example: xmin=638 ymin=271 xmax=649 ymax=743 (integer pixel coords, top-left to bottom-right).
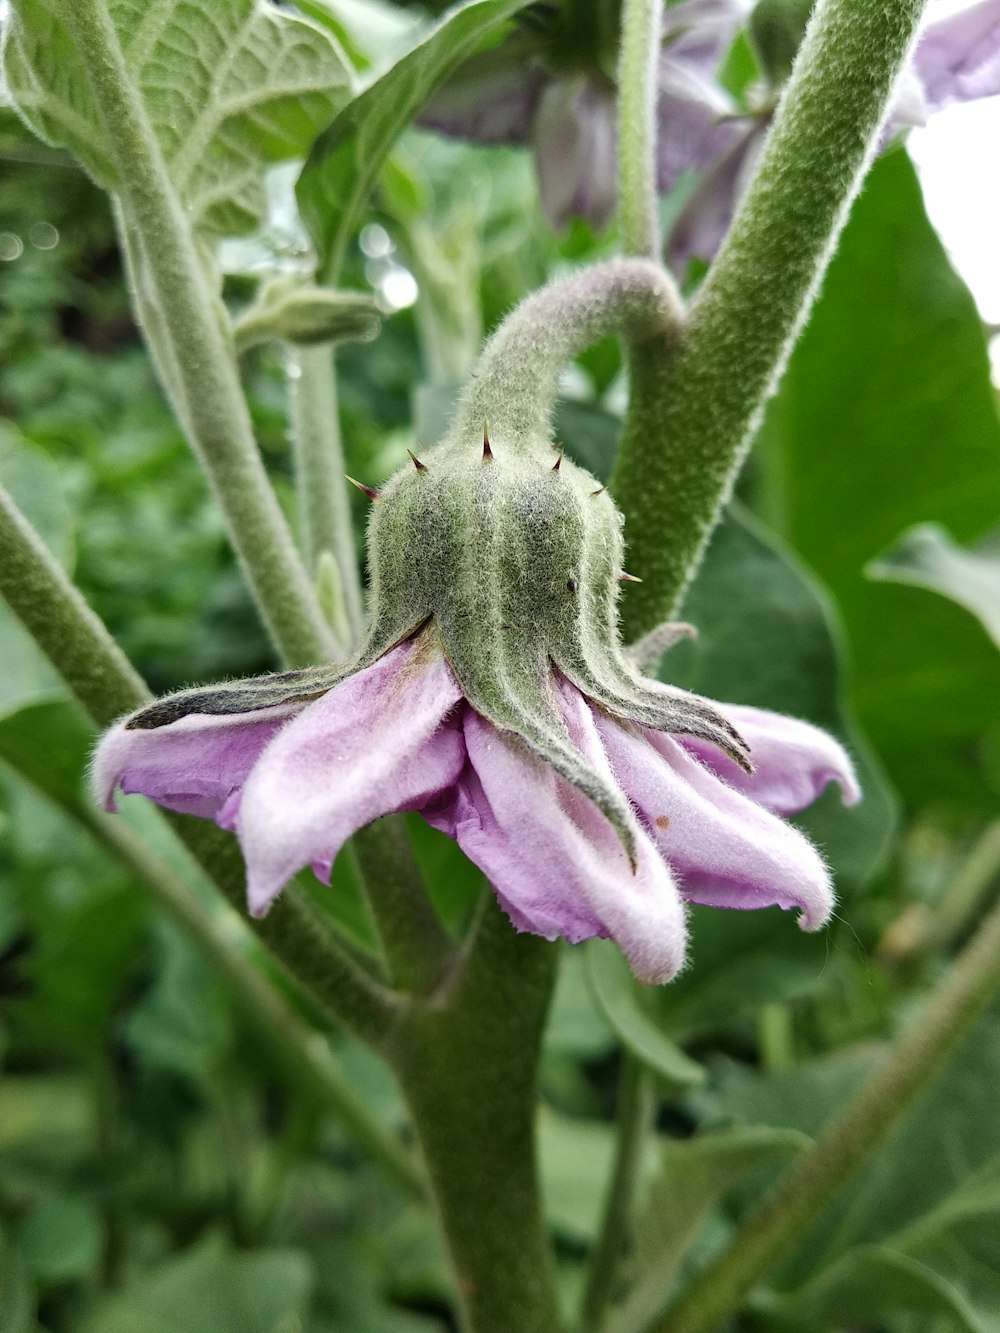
xmin=285 ymin=344 xmax=364 ymax=647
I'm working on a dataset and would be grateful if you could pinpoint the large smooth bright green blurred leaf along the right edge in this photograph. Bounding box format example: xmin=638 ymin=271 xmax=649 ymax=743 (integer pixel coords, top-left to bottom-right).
xmin=757 ymin=152 xmax=1000 ymax=802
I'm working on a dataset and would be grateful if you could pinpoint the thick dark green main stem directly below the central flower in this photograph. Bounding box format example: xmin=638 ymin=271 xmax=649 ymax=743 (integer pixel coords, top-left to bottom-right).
xmin=387 ymin=897 xmax=560 ymax=1333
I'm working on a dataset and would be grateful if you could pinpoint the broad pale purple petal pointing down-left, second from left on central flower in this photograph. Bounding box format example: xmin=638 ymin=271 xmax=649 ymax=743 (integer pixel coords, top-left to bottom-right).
xmin=236 ymin=635 xmax=465 ymax=916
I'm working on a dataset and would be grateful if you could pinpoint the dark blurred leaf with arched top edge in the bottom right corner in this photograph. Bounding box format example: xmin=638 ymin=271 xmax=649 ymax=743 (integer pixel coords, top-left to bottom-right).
xmin=760 ymin=1245 xmax=987 ymax=1333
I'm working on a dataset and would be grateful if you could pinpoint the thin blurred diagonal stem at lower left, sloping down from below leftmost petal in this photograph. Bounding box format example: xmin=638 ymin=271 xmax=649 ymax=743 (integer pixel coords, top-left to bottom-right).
xmin=92 ymin=814 xmax=425 ymax=1197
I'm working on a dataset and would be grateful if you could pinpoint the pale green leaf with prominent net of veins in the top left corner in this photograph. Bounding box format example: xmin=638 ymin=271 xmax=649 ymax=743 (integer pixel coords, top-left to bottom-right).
xmin=4 ymin=0 xmax=351 ymax=236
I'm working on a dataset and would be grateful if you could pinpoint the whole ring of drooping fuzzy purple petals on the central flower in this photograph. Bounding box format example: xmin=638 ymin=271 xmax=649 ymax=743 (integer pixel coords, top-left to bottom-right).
xmin=92 ymin=623 xmax=860 ymax=982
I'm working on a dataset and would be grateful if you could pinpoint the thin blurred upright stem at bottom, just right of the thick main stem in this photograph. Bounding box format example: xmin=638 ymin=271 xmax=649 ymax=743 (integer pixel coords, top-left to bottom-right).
xmin=580 ymin=1052 xmax=656 ymax=1333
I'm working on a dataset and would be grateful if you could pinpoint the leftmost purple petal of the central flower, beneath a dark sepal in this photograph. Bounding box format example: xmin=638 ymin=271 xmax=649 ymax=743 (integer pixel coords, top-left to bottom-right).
xmin=91 ymin=704 xmax=304 ymax=818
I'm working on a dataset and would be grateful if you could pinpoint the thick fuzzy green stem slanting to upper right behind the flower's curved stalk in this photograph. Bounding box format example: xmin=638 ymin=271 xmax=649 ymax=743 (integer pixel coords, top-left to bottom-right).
xmin=612 ymin=0 xmax=923 ymax=639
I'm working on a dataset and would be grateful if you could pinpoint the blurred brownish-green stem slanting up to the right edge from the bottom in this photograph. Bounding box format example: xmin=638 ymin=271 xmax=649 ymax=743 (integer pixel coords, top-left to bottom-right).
xmin=653 ymin=885 xmax=1000 ymax=1333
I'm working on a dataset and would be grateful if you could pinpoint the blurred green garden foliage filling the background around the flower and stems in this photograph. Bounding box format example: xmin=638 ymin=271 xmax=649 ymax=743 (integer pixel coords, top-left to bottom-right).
xmin=0 ymin=0 xmax=1000 ymax=1333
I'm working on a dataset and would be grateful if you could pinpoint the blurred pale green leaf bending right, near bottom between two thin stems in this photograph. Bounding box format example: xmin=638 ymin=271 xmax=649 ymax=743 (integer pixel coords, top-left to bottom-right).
xmin=611 ymin=1125 xmax=809 ymax=1333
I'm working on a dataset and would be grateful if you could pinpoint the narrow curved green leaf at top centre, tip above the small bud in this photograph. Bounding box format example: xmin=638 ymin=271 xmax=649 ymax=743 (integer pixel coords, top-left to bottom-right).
xmin=297 ymin=0 xmax=527 ymax=281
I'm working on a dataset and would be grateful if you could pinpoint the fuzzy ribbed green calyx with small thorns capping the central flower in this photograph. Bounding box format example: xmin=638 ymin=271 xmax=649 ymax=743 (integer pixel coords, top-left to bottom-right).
xmin=359 ymin=428 xmax=748 ymax=854
